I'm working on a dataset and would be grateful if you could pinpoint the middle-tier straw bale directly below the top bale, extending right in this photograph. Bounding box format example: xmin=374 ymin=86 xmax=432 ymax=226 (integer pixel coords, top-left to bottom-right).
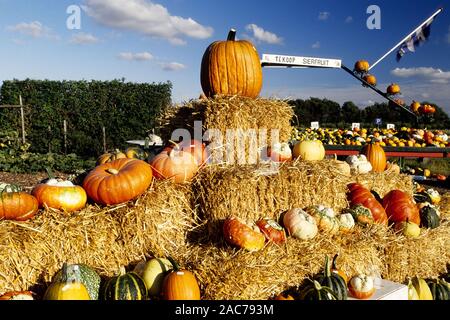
xmin=193 ymin=159 xmax=412 ymax=236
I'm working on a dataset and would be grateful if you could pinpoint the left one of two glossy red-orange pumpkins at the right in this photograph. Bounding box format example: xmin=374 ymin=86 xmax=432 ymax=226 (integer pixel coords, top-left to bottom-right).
xmin=347 ymin=183 xmax=388 ymax=225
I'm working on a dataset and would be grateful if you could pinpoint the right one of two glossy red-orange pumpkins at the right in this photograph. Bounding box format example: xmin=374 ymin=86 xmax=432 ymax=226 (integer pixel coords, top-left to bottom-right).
xmin=383 ymin=190 xmax=420 ymax=225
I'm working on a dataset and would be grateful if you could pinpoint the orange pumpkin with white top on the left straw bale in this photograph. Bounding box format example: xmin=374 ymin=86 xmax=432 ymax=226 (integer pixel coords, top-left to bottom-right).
xmin=31 ymin=179 xmax=87 ymax=212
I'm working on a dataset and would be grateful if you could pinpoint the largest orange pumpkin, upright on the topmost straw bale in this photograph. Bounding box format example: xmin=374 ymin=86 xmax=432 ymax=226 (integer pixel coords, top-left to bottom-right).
xmin=200 ymin=29 xmax=262 ymax=98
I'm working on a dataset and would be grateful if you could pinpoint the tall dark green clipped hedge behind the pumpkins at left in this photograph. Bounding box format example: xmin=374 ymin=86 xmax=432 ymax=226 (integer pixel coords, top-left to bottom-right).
xmin=0 ymin=79 xmax=172 ymax=157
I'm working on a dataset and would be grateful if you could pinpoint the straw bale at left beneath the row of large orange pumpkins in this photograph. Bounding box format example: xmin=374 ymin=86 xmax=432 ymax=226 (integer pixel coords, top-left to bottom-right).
xmin=0 ymin=182 xmax=197 ymax=292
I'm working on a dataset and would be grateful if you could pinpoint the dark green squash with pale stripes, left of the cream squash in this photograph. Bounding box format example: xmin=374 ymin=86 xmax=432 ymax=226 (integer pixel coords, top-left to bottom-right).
xmin=102 ymin=267 xmax=147 ymax=300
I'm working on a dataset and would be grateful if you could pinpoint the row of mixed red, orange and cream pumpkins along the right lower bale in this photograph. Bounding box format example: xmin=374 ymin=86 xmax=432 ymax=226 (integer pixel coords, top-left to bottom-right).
xmin=222 ymin=183 xmax=440 ymax=252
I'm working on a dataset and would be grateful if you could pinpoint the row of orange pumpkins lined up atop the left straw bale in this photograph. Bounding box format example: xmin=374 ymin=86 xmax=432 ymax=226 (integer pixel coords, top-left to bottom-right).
xmin=0 ymin=140 xmax=207 ymax=221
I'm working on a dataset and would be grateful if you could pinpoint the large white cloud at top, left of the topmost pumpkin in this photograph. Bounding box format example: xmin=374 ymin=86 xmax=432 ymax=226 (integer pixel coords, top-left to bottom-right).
xmin=83 ymin=0 xmax=213 ymax=44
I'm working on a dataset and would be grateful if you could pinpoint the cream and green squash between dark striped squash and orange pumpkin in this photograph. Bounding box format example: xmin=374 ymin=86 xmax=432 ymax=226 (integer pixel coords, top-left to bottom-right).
xmin=134 ymin=258 xmax=173 ymax=296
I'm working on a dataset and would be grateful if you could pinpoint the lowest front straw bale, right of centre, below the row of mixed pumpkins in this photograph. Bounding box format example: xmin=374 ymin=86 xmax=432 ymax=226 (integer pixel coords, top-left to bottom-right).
xmin=179 ymin=225 xmax=385 ymax=300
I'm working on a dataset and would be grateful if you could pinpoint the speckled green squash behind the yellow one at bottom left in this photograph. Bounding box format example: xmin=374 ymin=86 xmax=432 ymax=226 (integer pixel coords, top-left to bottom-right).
xmin=53 ymin=264 xmax=101 ymax=300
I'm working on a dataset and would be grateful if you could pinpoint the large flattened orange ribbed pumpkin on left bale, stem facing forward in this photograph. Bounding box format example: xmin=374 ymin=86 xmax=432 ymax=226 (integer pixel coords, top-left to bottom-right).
xmin=83 ymin=158 xmax=153 ymax=205
